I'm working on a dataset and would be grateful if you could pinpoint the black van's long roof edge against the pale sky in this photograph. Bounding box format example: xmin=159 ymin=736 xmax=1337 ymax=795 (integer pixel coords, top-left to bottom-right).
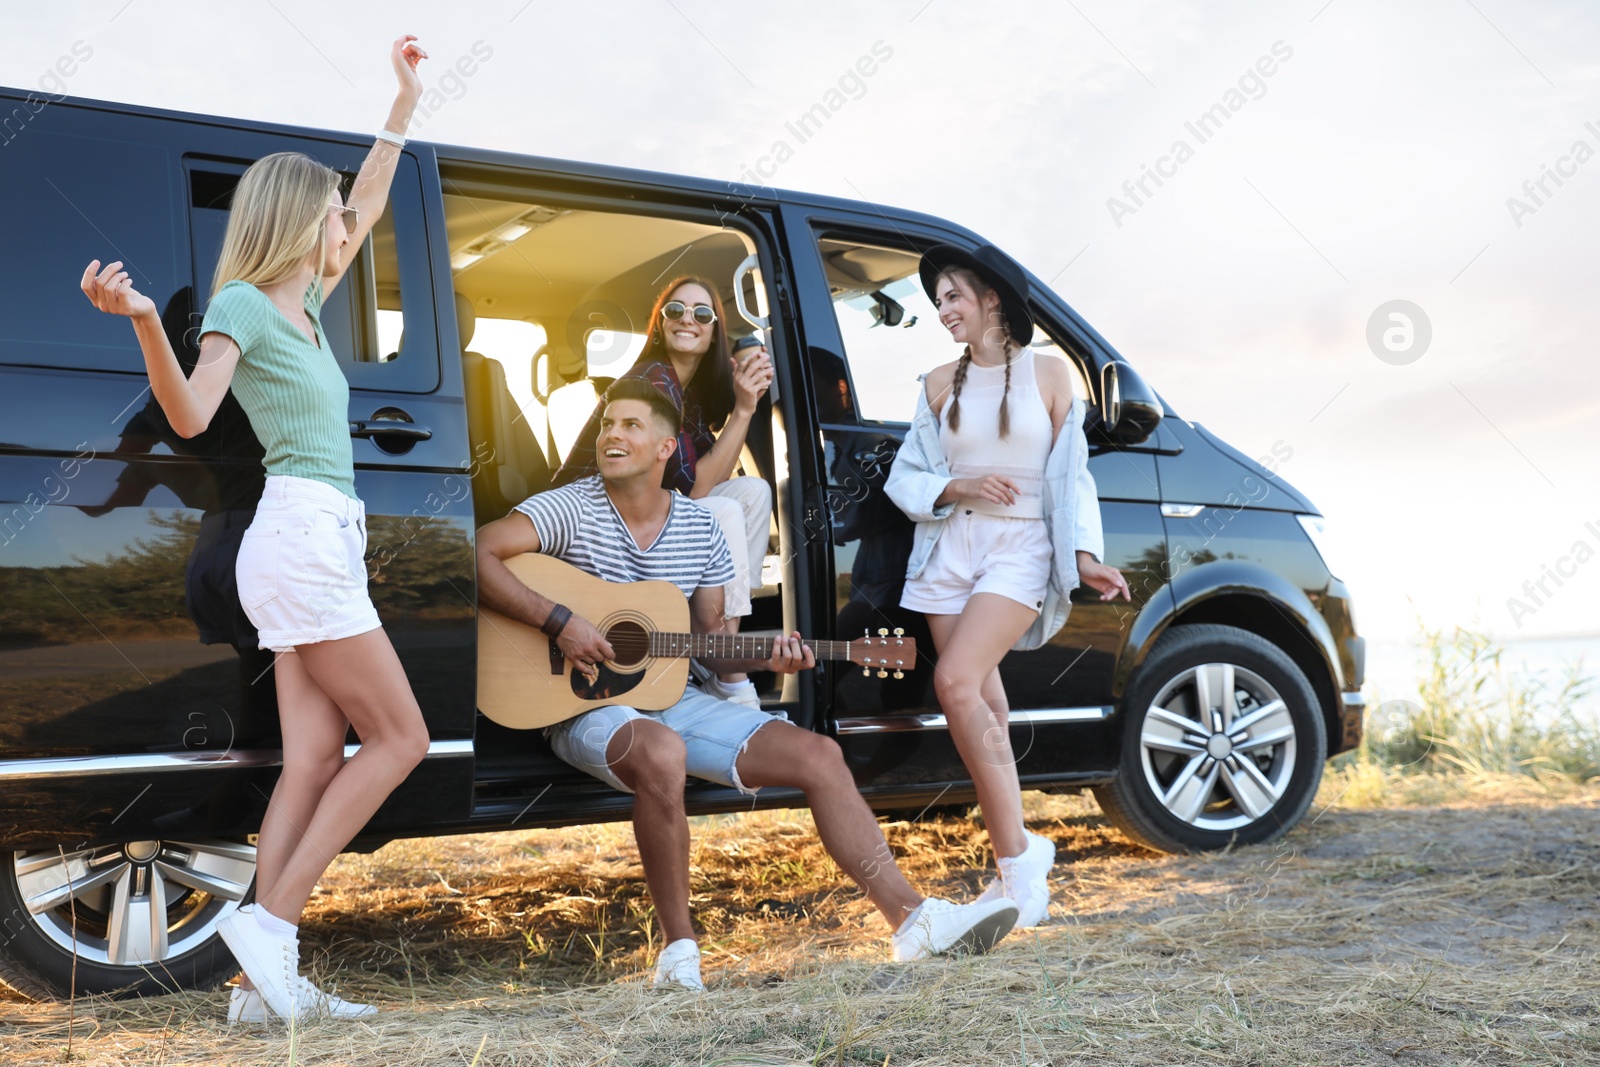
xmin=0 ymin=85 xmax=987 ymax=243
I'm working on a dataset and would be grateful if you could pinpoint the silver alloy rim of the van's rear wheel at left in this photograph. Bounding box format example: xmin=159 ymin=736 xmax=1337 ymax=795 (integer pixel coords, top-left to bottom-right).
xmin=14 ymin=840 xmax=256 ymax=968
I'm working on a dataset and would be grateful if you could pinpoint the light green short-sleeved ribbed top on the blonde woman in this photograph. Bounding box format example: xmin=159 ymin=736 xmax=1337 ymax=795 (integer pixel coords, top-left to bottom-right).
xmin=200 ymin=278 xmax=355 ymax=498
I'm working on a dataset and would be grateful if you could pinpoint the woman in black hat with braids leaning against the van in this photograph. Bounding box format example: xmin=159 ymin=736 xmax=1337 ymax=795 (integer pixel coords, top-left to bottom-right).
xmin=885 ymin=245 xmax=1131 ymax=926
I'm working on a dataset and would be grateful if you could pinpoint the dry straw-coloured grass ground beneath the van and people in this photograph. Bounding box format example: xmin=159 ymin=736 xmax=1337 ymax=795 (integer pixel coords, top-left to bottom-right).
xmin=0 ymin=776 xmax=1600 ymax=1067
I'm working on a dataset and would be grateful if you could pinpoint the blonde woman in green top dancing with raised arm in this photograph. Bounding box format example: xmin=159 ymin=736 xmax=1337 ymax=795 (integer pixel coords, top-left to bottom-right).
xmin=83 ymin=37 xmax=429 ymax=1021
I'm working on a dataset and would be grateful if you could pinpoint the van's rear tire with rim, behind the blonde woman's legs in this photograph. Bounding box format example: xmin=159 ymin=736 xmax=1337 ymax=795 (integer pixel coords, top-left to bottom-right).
xmin=0 ymin=841 xmax=256 ymax=998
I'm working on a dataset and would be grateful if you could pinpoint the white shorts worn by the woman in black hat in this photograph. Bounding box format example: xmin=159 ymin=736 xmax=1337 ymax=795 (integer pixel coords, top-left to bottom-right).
xmin=901 ymin=506 xmax=1051 ymax=614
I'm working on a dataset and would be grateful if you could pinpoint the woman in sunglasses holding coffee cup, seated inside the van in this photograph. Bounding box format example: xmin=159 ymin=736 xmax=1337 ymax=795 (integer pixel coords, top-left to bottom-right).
xmin=555 ymin=277 xmax=773 ymax=707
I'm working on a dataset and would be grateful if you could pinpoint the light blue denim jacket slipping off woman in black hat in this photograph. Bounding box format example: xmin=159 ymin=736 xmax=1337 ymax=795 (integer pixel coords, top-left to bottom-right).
xmin=883 ymin=374 xmax=1106 ymax=649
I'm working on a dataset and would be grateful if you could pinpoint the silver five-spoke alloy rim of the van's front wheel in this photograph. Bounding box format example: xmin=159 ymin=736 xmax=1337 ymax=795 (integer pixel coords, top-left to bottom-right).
xmin=1139 ymin=662 xmax=1298 ymax=832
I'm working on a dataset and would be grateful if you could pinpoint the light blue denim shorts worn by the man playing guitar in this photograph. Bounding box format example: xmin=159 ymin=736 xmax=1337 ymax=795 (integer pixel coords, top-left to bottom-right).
xmin=544 ymin=686 xmax=789 ymax=797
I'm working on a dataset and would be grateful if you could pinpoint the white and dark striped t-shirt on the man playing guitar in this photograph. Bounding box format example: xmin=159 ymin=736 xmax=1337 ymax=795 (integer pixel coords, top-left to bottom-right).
xmin=517 ymin=475 xmax=733 ymax=597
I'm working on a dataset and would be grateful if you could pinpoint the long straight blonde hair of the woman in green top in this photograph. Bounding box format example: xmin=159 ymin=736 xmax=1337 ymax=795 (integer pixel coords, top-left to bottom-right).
xmin=211 ymin=152 xmax=339 ymax=296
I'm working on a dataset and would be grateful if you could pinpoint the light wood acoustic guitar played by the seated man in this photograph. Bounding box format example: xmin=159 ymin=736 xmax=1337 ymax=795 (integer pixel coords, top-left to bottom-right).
xmin=478 ymin=552 xmax=917 ymax=729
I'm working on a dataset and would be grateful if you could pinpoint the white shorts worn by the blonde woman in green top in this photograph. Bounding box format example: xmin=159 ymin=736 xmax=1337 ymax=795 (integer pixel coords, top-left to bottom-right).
xmin=234 ymin=474 xmax=382 ymax=653
